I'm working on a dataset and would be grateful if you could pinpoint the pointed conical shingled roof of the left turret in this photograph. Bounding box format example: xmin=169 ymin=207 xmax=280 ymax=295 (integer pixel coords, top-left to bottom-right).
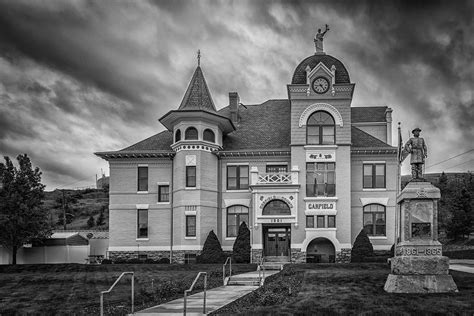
xmin=178 ymin=66 xmax=216 ymax=113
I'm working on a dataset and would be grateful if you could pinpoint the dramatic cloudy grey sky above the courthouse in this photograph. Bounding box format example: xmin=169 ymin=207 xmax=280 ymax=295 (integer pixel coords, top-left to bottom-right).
xmin=0 ymin=0 xmax=474 ymax=190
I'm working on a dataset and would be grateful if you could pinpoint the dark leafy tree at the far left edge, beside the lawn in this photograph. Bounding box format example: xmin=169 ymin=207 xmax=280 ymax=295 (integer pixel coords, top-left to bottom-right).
xmin=0 ymin=154 xmax=51 ymax=264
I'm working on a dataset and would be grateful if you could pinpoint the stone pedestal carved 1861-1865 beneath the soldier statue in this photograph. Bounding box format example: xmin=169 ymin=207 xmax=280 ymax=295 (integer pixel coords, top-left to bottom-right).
xmin=384 ymin=182 xmax=458 ymax=293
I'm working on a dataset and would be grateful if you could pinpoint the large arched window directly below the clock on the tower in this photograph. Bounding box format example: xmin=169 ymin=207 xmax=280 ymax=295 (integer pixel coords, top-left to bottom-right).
xmin=306 ymin=111 xmax=336 ymax=145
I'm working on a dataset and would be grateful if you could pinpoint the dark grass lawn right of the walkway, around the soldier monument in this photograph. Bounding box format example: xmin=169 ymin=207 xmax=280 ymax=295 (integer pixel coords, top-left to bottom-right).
xmin=213 ymin=263 xmax=474 ymax=315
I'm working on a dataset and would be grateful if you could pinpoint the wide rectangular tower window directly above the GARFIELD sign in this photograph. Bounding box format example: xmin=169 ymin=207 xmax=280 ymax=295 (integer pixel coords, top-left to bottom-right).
xmin=306 ymin=162 xmax=336 ymax=196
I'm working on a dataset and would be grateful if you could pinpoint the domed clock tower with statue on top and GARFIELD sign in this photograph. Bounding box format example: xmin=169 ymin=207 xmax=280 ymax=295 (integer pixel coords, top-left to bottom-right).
xmin=287 ymin=27 xmax=355 ymax=257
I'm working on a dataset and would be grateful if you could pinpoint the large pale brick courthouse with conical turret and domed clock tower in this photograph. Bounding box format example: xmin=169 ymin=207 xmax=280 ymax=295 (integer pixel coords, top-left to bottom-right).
xmin=96 ymin=38 xmax=397 ymax=262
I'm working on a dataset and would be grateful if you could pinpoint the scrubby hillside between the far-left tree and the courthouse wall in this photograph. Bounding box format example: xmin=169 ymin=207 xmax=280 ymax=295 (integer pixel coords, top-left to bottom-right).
xmin=44 ymin=189 xmax=109 ymax=229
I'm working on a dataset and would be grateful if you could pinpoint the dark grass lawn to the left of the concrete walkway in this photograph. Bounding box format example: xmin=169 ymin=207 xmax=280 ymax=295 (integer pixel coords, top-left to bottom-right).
xmin=0 ymin=264 xmax=256 ymax=316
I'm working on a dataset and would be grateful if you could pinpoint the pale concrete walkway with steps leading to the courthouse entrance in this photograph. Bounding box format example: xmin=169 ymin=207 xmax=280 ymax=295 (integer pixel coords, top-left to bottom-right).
xmin=135 ymin=271 xmax=279 ymax=316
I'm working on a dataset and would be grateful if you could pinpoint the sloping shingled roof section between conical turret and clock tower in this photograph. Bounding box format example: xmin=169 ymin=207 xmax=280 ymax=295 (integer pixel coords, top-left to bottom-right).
xmin=219 ymin=99 xmax=291 ymax=151
